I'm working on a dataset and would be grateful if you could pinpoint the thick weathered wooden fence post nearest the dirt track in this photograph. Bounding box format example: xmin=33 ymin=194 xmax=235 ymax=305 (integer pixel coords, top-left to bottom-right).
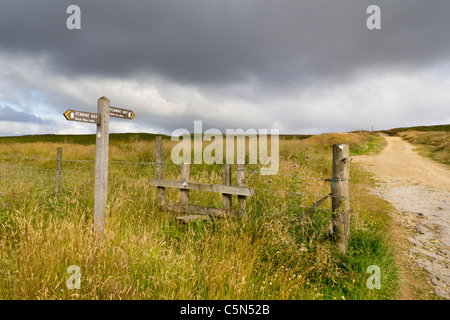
xmin=331 ymin=144 xmax=350 ymax=253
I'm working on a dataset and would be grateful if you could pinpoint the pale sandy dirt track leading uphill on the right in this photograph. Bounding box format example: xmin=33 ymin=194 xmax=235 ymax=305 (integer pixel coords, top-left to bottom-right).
xmin=352 ymin=136 xmax=450 ymax=299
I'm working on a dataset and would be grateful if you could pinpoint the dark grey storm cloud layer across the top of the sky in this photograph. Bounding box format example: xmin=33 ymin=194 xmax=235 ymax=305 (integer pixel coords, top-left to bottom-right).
xmin=0 ymin=0 xmax=450 ymax=89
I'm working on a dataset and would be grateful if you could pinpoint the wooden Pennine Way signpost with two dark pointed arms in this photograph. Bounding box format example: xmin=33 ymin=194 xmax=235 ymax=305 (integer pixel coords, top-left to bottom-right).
xmin=64 ymin=97 xmax=135 ymax=234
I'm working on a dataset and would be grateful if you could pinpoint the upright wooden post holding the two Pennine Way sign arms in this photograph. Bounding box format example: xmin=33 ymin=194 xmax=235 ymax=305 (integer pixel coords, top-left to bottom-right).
xmin=94 ymin=97 xmax=110 ymax=234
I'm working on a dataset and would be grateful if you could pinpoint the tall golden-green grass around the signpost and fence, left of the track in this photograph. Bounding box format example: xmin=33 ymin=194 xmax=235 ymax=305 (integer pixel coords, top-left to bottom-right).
xmin=0 ymin=133 xmax=398 ymax=299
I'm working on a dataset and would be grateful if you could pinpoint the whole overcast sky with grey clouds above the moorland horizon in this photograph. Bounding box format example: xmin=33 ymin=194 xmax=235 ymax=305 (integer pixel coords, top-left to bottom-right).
xmin=0 ymin=0 xmax=450 ymax=135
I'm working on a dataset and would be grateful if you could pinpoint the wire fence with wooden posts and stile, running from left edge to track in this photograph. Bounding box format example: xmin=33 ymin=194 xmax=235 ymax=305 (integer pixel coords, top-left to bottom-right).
xmin=0 ymin=142 xmax=358 ymax=252
